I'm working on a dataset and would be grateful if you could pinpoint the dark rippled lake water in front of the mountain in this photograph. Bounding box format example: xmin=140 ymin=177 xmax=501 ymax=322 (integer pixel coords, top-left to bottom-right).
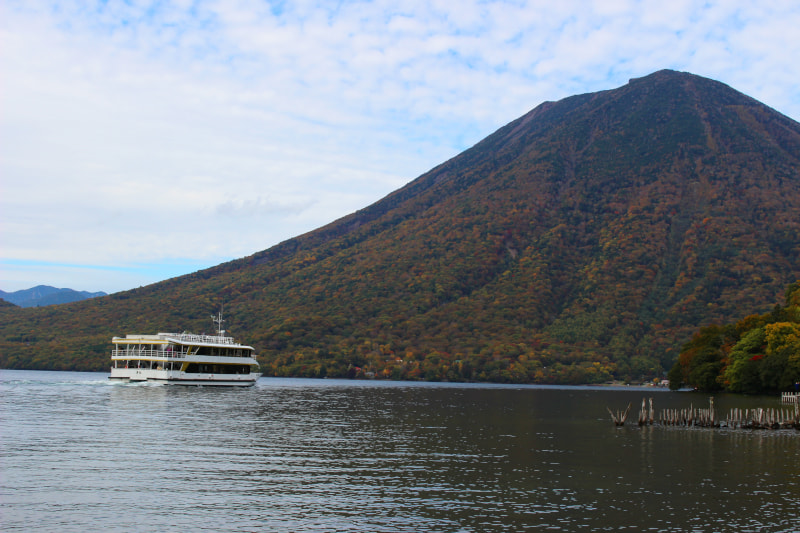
xmin=0 ymin=370 xmax=800 ymax=532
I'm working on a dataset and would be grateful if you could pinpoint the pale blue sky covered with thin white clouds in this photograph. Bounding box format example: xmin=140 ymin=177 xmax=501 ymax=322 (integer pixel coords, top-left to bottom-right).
xmin=0 ymin=0 xmax=800 ymax=293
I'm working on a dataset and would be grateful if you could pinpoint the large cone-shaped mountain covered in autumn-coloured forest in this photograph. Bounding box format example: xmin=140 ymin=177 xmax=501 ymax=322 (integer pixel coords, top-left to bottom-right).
xmin=0 ymin=71 xmax=800 ymax=383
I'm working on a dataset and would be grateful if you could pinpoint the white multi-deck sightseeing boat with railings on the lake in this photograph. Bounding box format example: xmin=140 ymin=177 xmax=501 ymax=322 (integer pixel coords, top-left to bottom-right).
xmin=109 ymin=312 xmax=261 ymax=387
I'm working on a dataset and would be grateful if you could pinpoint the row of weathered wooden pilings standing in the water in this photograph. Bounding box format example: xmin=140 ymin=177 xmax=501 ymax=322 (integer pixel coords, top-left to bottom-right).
xmin=606 ymin=397 xmax=800 ymax=431
